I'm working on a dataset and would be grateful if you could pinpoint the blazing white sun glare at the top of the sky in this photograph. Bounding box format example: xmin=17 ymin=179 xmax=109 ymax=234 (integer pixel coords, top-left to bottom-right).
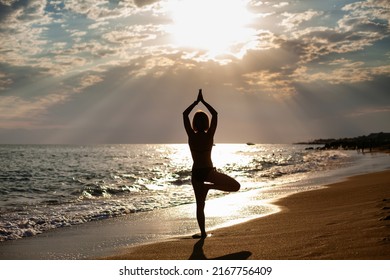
xmin=165 ymin=0 xmax=254 ymax=55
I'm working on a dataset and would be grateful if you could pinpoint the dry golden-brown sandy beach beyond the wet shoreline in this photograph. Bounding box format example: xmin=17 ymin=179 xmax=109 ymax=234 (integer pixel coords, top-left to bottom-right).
xmin=105 ymin=170 xmax=390 ymax=260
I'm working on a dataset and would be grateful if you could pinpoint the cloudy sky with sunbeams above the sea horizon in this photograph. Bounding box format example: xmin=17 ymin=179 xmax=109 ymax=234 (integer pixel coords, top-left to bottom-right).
xmin=0 ymin=0 xmax=390 ymax=143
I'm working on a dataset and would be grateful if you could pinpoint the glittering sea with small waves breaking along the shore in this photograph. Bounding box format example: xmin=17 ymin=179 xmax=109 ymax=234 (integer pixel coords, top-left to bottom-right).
xmin=0 ymin=143 xmax=390 ymax=242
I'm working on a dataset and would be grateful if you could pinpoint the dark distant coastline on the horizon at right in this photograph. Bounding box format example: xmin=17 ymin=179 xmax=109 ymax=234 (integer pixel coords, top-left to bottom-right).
xmin=295 ymin=132 xmax=390 ymax=151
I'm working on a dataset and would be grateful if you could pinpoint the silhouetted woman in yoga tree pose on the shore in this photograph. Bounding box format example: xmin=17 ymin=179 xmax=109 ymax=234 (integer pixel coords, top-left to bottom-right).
xmin=183 ymin=89 xmax=240 ymax=238
